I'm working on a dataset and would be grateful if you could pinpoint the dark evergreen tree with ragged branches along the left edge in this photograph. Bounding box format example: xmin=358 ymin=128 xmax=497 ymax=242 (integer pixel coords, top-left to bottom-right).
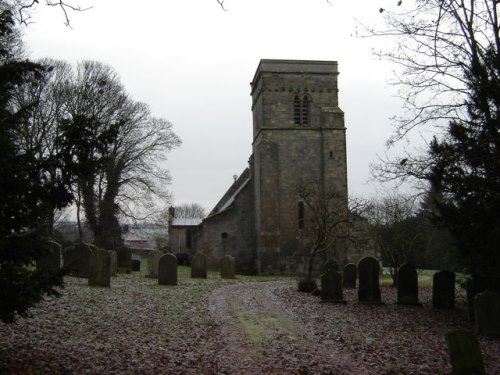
xmin=0 ymin=9 xmax=71 ymax=322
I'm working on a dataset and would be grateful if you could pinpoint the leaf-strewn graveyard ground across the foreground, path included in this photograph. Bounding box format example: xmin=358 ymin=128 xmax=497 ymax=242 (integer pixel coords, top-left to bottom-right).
xmin=0 ymin=262 xmax=500 ymax=375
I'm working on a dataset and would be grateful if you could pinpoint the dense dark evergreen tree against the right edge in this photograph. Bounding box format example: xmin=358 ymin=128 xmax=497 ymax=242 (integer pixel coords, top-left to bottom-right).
xmin=429 ymin=46 xmax=500 ymax=291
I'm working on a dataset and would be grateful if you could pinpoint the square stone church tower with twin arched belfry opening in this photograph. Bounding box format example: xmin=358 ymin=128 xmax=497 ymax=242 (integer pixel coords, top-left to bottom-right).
xmin=250 ymin=60 xmax=347 ymax=272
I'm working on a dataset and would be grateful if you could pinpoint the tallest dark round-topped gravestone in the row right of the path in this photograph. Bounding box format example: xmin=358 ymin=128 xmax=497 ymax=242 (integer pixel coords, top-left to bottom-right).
xmin=358 ymin=257 xmax=382 ymax=303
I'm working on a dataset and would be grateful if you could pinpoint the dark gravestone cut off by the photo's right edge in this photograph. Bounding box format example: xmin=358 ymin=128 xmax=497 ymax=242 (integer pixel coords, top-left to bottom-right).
xmin=474 ymin=290 xmax=500 ymax=336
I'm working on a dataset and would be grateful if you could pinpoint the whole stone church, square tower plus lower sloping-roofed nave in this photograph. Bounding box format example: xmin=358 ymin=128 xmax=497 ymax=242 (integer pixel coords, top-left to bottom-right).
xmin=172 ymin=59 xmax=349 ymax=274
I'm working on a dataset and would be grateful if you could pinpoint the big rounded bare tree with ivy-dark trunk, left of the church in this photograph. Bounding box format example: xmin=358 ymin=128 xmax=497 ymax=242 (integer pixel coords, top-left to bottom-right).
xmin=60 ymin=61 xmax=180 ymax=248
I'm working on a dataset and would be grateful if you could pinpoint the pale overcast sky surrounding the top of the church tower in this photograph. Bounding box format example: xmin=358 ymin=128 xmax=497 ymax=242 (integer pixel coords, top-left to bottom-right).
xmin=25 ymin=0 xmax=406 ymax=209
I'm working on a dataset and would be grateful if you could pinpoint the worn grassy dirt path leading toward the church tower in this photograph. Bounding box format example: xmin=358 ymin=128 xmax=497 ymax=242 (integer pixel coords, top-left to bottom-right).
xmin=209 ymin=282 xmax=360 ymax=374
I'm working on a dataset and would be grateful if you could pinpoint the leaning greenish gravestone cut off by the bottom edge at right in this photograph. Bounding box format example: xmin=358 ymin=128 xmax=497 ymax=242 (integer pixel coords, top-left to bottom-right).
xmin=446 ymin=331 xmax=486 ymax=375
